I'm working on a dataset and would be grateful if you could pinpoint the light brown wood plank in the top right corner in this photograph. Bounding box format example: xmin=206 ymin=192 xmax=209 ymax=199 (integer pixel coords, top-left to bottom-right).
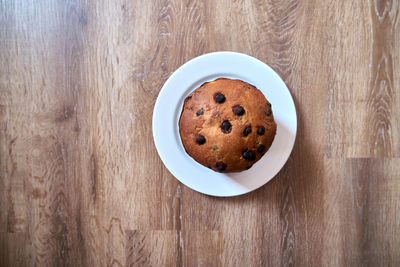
xmin=327 ymin=1 xmax=400 ymax=157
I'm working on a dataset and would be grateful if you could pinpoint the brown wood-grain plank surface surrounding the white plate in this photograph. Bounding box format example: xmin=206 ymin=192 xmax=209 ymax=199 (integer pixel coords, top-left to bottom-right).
xmin=0 ymin=0 xmax=400 ymax=266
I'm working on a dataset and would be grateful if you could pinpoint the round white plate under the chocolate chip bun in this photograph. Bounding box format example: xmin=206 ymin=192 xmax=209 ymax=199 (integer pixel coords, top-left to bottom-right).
xmin=153 ymin=52 xmax=297 ymax=197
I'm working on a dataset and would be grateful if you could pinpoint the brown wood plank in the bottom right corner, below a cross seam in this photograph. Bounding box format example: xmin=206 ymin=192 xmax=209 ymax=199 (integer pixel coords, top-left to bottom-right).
xmin=322 ymin=158 xmax=400 ymax=266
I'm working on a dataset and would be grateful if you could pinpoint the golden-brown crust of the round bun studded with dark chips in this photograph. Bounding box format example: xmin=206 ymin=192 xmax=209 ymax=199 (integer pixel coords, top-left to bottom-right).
xmin=179 ymin=78 xmax=276 ymax=172
